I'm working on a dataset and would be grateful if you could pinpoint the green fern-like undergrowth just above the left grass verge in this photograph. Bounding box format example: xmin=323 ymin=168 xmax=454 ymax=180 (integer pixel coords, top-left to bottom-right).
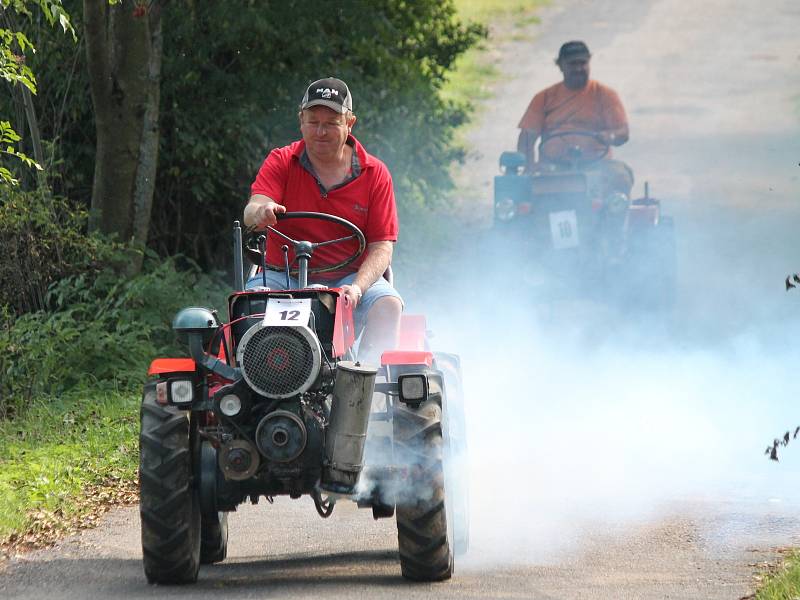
xmin=0 ymin=256 xmax=226 ymax=417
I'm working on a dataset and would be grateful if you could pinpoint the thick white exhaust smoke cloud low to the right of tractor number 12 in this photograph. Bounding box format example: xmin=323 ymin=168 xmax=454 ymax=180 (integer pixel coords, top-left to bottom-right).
xmin=416 ymin=255 xmax=800 ymax=563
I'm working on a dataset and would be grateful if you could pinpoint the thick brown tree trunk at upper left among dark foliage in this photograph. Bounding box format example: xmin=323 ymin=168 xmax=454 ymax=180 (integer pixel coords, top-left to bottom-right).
xmin=83 ymin=0 xmax=163 ymax=272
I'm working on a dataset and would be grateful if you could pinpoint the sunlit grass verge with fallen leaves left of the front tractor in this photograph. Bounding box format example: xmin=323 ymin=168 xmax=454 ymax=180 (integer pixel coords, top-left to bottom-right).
xmin=0 ymin=389 xmax=139 ymax=556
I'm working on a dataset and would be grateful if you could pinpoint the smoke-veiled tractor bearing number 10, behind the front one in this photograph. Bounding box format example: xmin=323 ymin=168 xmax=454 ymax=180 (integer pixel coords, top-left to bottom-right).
xmin=490 ymin=130 xmax=677 ymax=308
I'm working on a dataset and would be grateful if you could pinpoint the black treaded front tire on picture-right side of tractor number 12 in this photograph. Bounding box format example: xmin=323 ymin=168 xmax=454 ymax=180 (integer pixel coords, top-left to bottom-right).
xmin=392 ymin=400 xmax=453 ymax=581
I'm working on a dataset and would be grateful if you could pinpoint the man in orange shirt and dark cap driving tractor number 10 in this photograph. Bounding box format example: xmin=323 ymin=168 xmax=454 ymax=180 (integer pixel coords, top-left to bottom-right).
xmin=517 ymin=41 xmax=633 ymax=195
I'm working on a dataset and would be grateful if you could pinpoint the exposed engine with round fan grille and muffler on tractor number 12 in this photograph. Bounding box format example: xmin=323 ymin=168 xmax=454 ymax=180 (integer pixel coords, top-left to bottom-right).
xmin=186 ymin=292 xmax=376 ymax=510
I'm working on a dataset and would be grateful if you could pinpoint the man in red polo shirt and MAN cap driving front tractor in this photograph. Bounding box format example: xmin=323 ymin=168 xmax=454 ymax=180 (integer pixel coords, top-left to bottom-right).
xmin=244 ymin=78 xmax=403 ymax=362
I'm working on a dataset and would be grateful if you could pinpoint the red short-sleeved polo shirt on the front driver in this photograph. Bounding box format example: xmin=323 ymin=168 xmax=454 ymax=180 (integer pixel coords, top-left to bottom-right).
xmin=250 ymin=135 xmax=398 ymax=279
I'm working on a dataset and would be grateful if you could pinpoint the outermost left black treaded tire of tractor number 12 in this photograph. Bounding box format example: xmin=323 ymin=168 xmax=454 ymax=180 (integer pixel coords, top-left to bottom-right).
xmin=139 ymin=383 xmax=200 ymax=584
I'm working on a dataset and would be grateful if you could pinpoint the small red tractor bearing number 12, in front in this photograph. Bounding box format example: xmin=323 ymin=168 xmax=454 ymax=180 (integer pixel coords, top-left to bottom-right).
xmin=139 ymin=213 xmax=468 ymax=584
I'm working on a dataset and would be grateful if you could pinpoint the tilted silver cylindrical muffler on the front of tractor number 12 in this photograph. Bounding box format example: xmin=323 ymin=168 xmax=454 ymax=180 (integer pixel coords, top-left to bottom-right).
xmin=320 ymin=361 xmax=378 ymax=494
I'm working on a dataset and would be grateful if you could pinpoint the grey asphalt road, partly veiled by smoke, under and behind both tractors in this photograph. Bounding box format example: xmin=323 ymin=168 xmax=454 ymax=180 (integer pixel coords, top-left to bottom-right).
xmin=0 ymin=0 xmax=800 ymax=599
